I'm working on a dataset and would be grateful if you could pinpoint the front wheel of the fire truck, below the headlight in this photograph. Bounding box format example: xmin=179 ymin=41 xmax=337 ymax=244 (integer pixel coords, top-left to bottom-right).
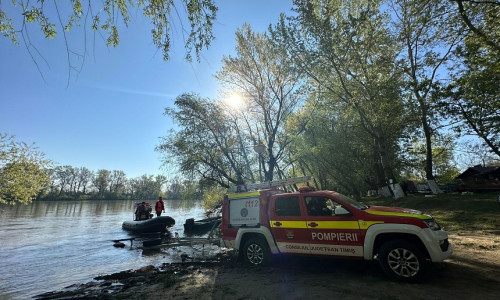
xmin=378 ymin=240 xmax=428 ymax=282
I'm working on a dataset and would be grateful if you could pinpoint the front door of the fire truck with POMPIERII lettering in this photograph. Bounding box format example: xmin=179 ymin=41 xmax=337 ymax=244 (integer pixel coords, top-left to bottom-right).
xmin=303 ymin=195 xmax=363 ymax=257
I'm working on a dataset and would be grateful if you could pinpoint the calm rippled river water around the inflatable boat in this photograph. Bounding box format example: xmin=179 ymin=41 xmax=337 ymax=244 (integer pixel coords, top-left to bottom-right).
xmin=0 ymin=200 xmax=211 ymax=299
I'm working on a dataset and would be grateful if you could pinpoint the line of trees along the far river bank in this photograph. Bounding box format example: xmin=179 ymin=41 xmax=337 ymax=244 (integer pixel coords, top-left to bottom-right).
xmin=0 ymin=133 xmax=200 ymax=204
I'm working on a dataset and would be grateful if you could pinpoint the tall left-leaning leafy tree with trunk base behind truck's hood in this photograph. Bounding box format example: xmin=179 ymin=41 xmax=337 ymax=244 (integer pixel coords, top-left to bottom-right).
xmin=273 ymin=0 xmax=405 ymax=198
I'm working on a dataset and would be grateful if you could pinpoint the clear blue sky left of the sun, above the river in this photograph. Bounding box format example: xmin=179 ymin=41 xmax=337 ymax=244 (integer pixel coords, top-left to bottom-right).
xmin=0 ymin=0 xmax=292 ymax=178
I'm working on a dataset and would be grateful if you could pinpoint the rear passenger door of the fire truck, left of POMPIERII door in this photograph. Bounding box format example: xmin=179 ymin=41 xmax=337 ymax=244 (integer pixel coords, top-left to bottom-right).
xmin=269 ymin=195 xmax=310 ymax=254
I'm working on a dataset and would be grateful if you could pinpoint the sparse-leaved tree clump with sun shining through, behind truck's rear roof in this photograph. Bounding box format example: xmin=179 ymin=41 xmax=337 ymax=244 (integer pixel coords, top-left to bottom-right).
xmin=157 ymin=25 xmax=302 ymax=188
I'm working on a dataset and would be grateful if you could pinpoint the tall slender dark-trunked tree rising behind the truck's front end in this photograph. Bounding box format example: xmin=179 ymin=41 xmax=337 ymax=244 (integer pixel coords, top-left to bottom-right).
xmin=391 ymin=0 xmax=461 ymax=193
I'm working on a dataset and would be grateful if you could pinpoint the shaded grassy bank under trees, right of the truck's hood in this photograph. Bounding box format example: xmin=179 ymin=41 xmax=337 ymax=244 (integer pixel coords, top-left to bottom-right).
xmin=363 ymin=192 xmax=500 ymax=235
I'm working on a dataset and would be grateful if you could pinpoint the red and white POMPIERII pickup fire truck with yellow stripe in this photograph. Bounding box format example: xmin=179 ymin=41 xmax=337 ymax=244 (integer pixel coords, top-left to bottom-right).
xmin=222 ymin=177 xmax=452 ymax=282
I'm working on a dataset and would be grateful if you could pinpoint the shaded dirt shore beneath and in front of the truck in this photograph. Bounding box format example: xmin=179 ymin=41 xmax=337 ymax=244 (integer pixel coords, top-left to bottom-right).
xmin=35 ymin=233 xmax=500 ymax=300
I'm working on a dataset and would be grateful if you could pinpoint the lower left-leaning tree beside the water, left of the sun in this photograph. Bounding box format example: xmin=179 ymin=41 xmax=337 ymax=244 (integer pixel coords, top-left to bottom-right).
xmin=156 ymin=94 xmax=245 ymax=188
